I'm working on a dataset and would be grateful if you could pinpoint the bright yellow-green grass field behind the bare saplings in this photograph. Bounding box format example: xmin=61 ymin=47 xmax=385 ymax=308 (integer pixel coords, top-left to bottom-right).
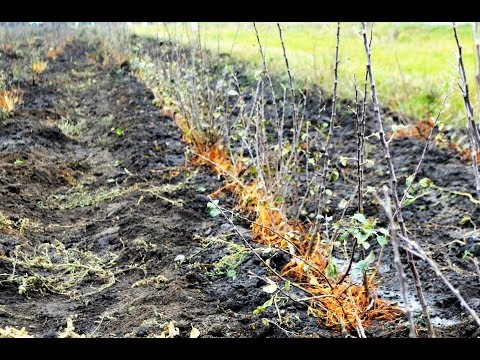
xmin=132 ymin=22 xmax=478 ymax=126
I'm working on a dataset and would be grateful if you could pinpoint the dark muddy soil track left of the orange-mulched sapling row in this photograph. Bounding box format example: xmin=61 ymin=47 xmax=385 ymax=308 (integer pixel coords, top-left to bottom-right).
xmin=0 ymin=39 xmax=322 ymax=337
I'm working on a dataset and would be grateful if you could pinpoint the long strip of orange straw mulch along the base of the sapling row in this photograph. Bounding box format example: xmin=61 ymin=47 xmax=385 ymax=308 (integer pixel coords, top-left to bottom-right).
xmin=142 ymin=76 xmax=401 ymax=330
